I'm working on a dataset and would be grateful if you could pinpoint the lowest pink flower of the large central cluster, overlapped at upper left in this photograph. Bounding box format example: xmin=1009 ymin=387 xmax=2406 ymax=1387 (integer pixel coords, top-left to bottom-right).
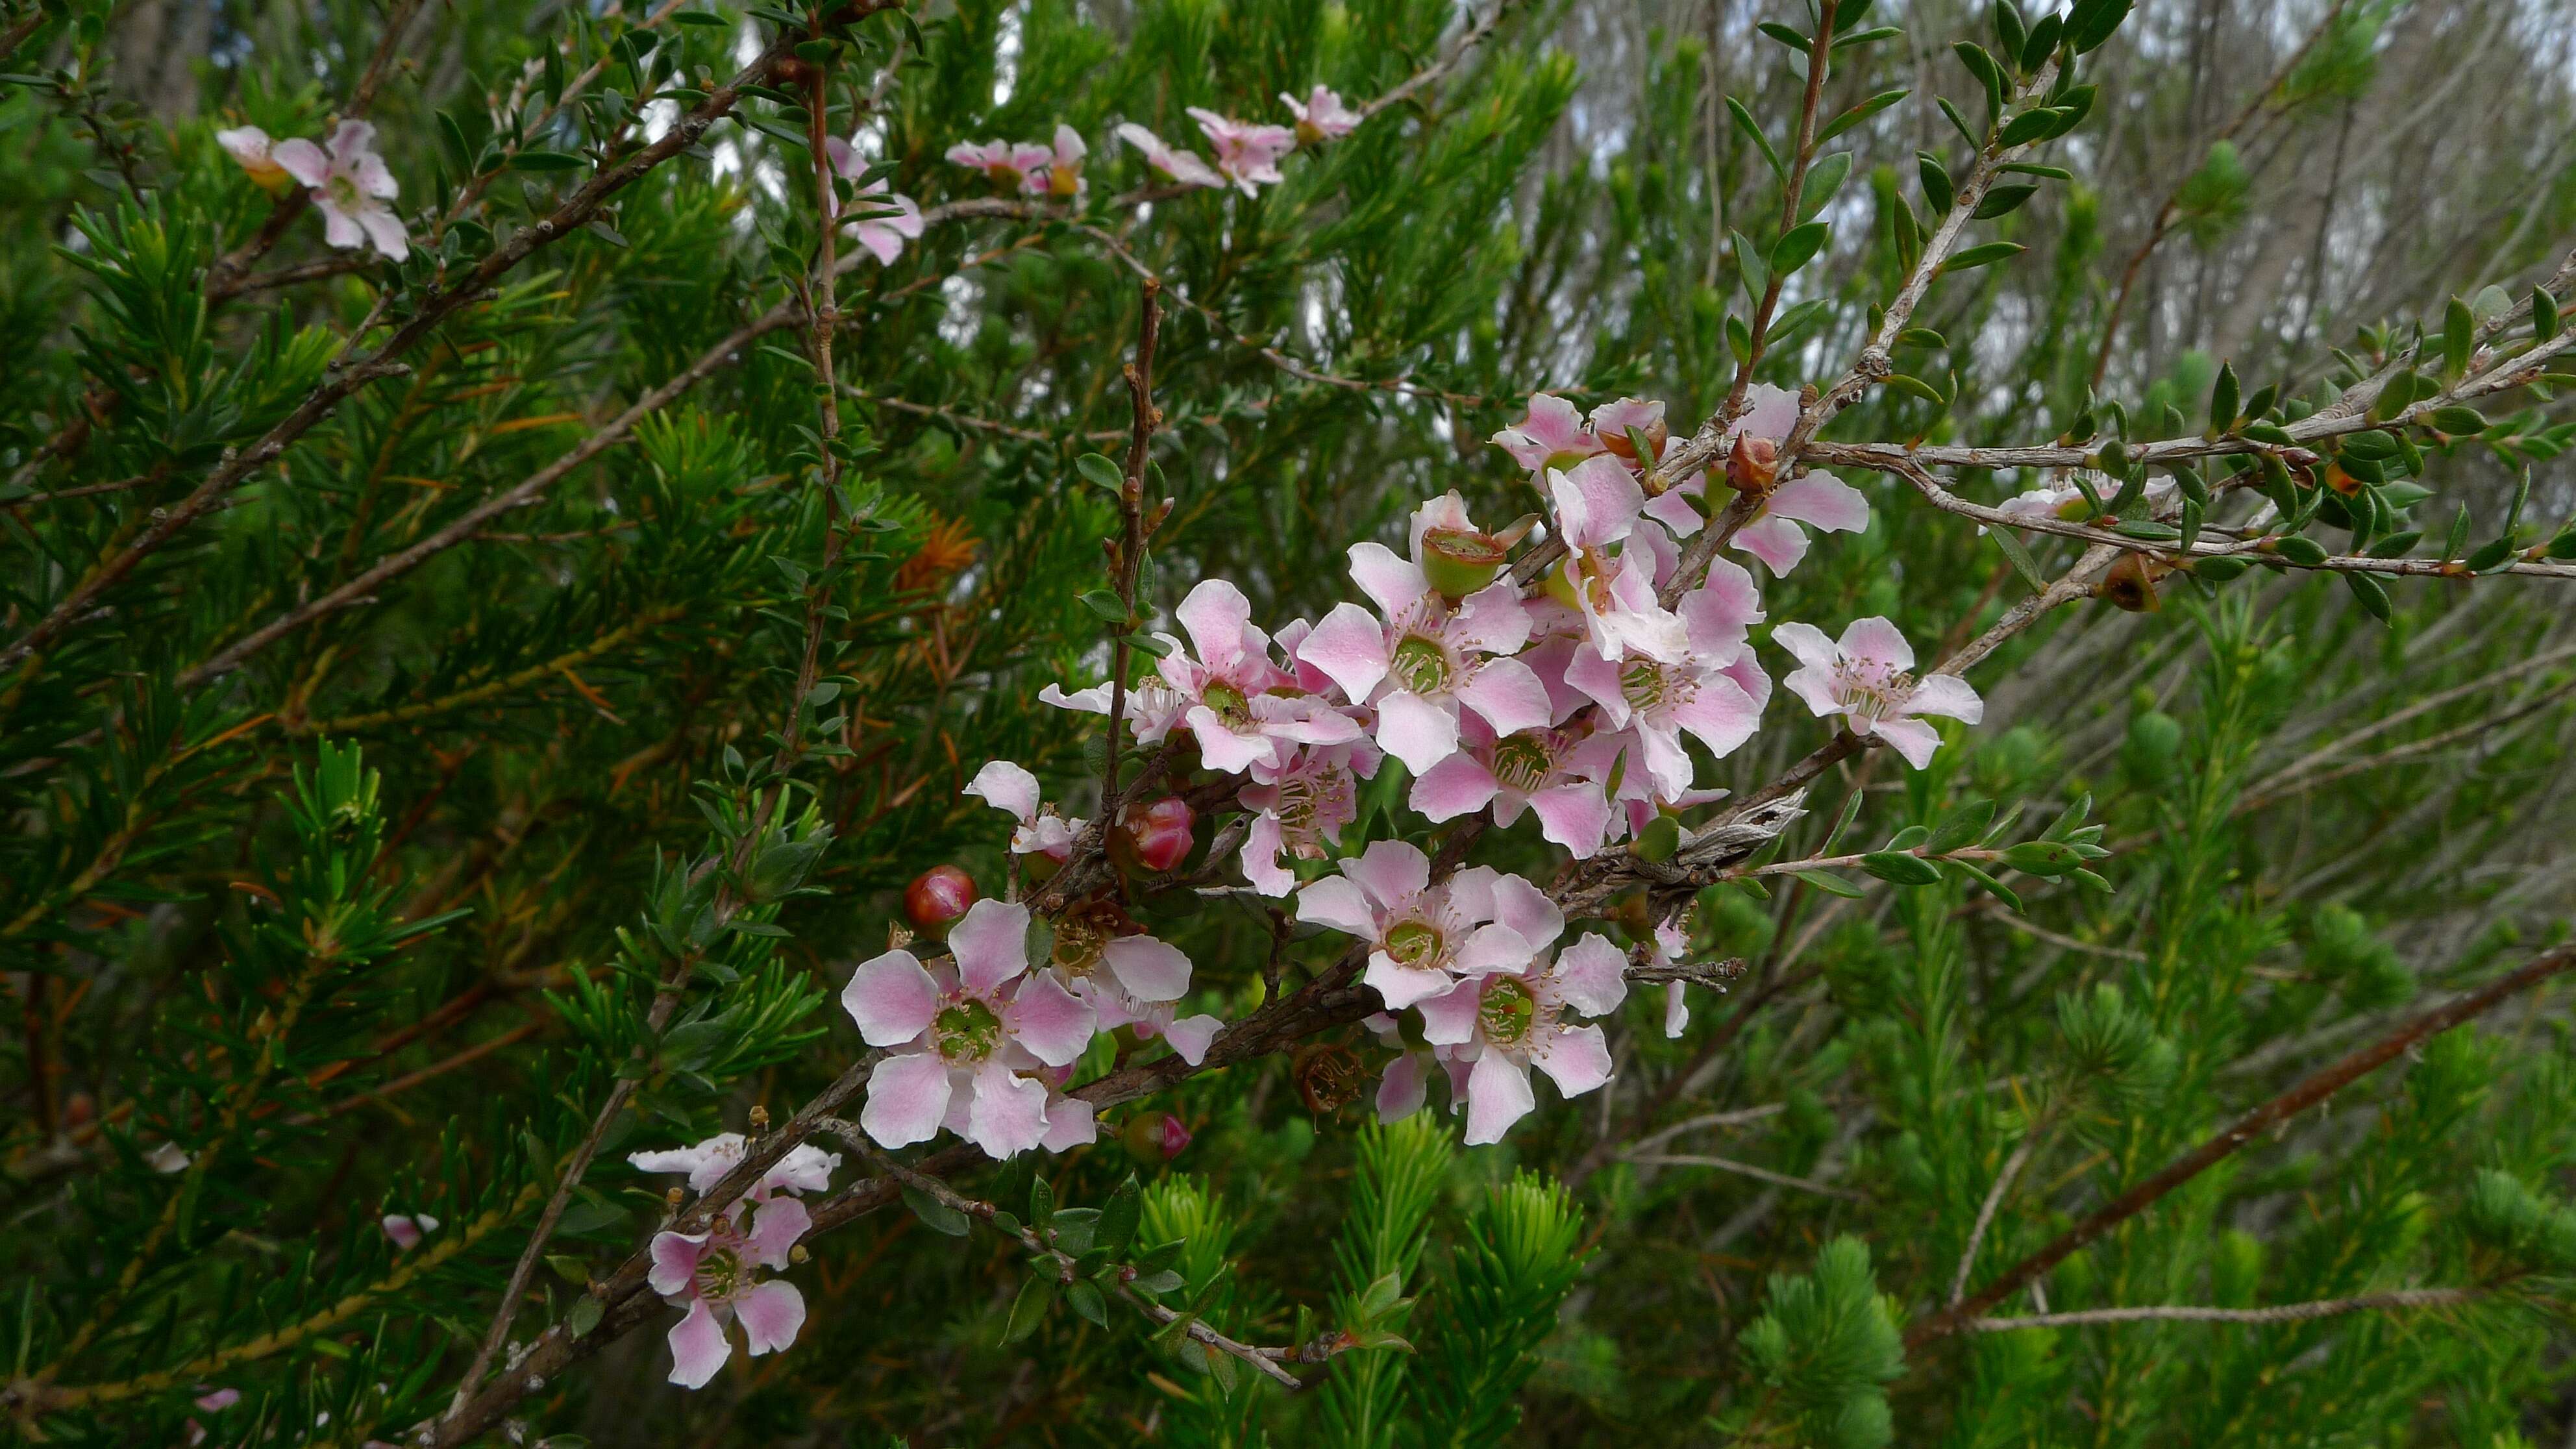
xmin=1419 ymin=934 xmax=1628 ymax=1147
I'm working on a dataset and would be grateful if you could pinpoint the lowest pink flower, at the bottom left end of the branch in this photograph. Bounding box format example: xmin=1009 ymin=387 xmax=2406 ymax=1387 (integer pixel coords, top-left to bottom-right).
xmin=647 ymin=1196 xmax=814 ymax=1390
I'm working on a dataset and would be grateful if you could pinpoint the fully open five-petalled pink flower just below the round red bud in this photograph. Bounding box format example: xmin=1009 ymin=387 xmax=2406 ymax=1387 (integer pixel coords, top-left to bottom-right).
xmin=840 ymin=900 xmax=1092 ymax=1158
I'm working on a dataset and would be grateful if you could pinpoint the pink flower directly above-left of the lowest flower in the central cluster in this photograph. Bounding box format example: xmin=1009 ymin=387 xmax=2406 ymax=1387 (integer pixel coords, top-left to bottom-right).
xmin=1296 ymin=841 xmax=1567 ymax=1011
